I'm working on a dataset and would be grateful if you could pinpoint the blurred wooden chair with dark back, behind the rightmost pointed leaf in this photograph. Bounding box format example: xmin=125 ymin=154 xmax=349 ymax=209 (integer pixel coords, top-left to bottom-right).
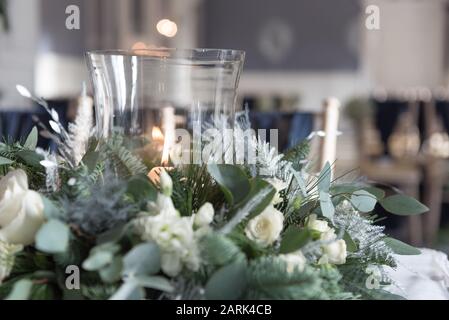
xmin=354 ymin=95 xmax=423 ymax=245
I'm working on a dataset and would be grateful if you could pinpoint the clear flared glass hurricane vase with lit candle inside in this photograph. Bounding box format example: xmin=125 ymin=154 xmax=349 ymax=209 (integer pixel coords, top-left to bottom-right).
xmin=87 ymin=48 xmax=245 ymax=166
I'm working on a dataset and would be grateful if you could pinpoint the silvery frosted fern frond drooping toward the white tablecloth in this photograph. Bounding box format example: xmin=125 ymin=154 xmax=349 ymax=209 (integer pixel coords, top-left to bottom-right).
xmin=334 ymin=201 xmax=396 ymax=267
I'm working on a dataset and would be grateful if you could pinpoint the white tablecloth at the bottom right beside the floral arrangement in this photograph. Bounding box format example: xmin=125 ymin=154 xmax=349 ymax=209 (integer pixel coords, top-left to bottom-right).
xmin=387 ymin=249 xmax=449 ymax=300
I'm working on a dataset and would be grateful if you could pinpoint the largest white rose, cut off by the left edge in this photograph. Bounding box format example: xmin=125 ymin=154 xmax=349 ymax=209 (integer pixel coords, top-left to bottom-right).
xmin=0 ymin=169 xmax=45 ymax=245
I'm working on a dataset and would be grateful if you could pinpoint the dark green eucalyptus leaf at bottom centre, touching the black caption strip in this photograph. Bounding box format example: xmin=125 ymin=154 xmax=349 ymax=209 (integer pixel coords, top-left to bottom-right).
xmin=205 ymin=260 xmax=247 ymax=300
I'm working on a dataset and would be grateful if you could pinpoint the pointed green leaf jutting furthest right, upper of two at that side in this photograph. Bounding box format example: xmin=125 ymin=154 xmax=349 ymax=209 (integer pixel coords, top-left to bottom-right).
xmin=379 ymin=194 xmax=429 ymax=216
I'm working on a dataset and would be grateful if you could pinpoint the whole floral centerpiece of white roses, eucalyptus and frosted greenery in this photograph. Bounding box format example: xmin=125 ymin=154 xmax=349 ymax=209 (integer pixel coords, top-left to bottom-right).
xmin=0 ymin=83 xmax=427 ymax=299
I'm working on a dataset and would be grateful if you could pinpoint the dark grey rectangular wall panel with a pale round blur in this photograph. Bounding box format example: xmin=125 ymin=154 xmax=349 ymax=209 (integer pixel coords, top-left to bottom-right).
xmin=201 ymin=0 xmax=361 ymax=71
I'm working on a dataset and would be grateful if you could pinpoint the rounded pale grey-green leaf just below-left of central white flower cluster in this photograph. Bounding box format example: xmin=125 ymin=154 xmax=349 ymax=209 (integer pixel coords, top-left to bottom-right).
xmin=123 ymin=242 xmax=161 ymax=276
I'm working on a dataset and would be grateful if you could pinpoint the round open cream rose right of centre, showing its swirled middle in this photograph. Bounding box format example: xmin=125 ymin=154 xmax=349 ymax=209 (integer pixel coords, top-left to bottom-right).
xmin=245 ymin=206 xmax=284 ymax=246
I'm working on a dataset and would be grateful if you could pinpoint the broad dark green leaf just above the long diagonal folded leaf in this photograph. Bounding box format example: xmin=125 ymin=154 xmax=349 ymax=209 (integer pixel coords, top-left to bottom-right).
xmin=207 ymin=164 xmax=251 ymax=204
